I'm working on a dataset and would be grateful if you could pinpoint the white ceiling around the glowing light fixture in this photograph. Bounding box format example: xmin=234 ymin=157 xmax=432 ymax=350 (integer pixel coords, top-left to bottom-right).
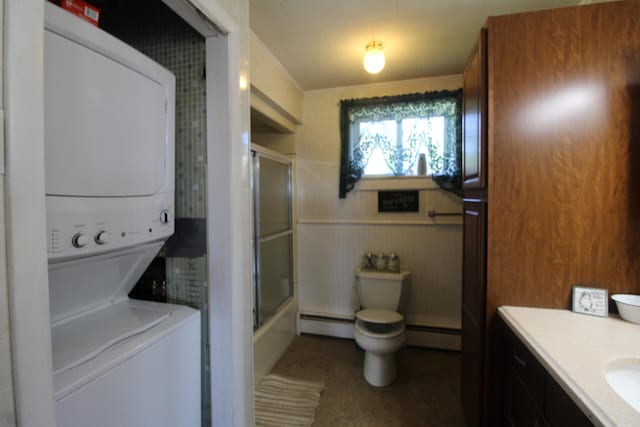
xmin=250 ymin=0 xmax=598 ymax=90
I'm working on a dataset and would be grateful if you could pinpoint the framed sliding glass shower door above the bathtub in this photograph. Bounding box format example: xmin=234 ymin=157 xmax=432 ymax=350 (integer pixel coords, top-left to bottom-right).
xmin=252 ymin=150 xmax=293 ymax=329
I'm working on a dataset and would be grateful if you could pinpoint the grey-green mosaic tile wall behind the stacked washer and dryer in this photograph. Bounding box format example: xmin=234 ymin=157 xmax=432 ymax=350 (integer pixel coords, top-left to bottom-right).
xmin=100 ymin=0 xmax=211 ymax=426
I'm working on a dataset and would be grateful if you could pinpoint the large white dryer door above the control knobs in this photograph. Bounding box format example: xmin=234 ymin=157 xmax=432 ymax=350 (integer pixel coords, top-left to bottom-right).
xmin=44 ymin=25 xmax=170 ymax=197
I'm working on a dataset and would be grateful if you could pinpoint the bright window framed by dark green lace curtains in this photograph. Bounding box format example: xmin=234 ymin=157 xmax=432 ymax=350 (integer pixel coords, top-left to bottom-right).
xmin=340 ymin=90 xmax=462 ymax=198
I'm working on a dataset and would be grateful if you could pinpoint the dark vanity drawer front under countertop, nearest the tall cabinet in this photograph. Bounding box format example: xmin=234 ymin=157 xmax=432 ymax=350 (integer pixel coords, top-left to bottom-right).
xmin=505 ymin=334 xmax=546 ymax=409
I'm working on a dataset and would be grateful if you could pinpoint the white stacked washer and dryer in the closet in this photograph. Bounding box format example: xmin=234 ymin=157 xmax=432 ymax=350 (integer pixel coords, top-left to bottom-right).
xmin=44 ymin=2 xmax=201 ymax=427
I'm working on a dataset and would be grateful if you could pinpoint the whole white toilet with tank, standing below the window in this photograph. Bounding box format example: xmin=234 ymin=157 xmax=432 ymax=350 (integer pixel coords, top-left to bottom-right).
xmin=353 ymin=268 xmax=411 ymax=387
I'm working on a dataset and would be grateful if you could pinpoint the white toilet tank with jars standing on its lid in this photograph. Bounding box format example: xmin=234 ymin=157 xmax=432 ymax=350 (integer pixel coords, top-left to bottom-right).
xmin=356 ymin=268 xmax=411 ymax=312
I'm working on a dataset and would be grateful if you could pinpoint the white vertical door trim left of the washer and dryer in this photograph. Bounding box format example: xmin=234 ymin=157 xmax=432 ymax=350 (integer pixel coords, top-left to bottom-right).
xmin=4 ymin=0 xmax=55 ymax=426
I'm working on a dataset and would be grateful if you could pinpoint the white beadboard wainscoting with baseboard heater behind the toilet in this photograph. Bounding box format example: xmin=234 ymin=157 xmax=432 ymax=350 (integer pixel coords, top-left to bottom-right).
xmin=298 ymin=218 xmax=462 ymax=350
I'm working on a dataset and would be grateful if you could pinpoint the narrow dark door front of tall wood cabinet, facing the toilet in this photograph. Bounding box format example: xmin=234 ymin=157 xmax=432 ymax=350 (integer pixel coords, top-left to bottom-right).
xmin=461 ymin=30 xmax=487 ymax=426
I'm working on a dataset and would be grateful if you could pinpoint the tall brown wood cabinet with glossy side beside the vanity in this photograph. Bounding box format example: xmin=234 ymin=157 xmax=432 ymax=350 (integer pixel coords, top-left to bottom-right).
xmin=461 ymin=1 xmax=640 ymax=426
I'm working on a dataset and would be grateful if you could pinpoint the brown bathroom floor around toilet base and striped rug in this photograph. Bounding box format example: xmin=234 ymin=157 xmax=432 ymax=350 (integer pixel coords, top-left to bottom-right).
xmin=264 ymin=335 xmax=465 ymax=427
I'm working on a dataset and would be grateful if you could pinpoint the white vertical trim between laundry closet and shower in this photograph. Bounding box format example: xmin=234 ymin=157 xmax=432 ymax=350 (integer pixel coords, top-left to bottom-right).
xmin=206 ymin=17 xmax=254 ymax=427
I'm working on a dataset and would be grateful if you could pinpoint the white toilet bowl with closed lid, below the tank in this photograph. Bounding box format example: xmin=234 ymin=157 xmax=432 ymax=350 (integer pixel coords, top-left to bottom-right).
xmin=353 ymin=309 xmax=405 ymax=387
